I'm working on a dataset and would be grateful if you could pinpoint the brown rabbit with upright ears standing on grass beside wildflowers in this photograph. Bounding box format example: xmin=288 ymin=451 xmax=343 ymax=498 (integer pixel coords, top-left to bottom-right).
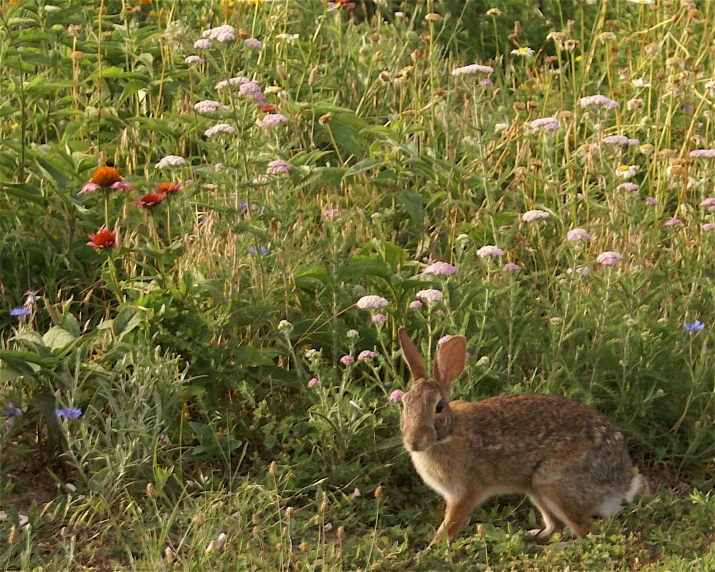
xmin=399 ymin=328 xmax=641 ymax=545
